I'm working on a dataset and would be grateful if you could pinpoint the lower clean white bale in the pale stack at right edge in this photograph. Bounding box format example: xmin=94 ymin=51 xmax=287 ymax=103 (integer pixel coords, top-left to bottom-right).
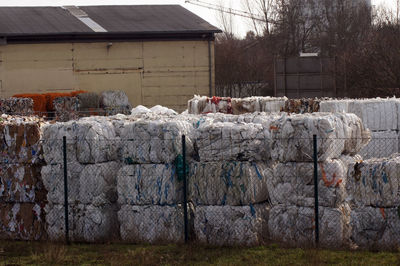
xmin=360 ymin=131 xmax=399 ymax=159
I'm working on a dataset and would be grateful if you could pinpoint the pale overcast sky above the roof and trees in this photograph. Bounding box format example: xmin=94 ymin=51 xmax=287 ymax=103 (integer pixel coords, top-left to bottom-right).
xmin=0 ymin=0 xmax=396 ymax=36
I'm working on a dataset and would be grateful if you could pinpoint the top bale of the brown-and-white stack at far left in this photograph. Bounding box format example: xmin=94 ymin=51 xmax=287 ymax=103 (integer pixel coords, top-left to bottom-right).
xmin=0 ymin=117 xmax=42 ymax=164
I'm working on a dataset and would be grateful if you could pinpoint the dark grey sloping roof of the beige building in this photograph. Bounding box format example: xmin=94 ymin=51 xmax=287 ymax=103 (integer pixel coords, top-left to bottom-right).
xmin=0 ymin=5 xmax=220 ymax=36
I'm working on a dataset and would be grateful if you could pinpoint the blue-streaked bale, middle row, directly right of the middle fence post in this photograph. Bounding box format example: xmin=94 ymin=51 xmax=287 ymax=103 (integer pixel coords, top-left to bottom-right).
xmin=188 ymin=162 xmax=270 ymax=206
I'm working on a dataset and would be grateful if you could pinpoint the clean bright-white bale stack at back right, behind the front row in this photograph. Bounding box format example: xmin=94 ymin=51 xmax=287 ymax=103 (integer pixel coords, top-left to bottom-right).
xmin=320 ymin=98 xmax=400 ymax=159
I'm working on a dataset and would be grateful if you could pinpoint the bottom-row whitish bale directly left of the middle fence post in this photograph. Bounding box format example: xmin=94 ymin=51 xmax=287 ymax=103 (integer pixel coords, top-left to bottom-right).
xmin=118 ymin=205 xmax=190 ymax=243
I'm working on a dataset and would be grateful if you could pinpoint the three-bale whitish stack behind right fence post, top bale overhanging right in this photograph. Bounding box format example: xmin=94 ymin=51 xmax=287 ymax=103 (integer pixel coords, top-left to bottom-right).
xmin=265 ymin=113 xmax=369 ymax=247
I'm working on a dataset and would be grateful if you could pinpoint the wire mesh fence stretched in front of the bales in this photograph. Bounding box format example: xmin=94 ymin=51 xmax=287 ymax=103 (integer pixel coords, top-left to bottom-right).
xmin=0 ymin=133 xmax=400 ymax=246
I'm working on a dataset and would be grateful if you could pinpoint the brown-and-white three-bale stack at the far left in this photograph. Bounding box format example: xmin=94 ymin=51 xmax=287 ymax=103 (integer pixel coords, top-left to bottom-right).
xmin=0 ymin=115 xmax=46 ymax=240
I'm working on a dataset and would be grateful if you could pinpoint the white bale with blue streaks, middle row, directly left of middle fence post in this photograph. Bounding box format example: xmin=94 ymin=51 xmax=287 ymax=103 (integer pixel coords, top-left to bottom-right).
xmin=117 ymin=164 xmax=183 ymax=205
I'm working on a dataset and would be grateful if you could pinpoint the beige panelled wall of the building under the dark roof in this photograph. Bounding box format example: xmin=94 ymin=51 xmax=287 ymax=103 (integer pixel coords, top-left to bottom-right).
xmin=0 ymin=41 xmax=214 ymax=111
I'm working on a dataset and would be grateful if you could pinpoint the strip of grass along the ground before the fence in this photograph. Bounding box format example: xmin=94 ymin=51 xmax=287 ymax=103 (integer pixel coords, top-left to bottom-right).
xmin=0 ymin=241 xmax=400 ymax=265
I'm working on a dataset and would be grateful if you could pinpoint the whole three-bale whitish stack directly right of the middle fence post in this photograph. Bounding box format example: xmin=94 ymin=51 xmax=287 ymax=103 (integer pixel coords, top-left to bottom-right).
xmin=188 ymin=115 xmax=272 ymax=245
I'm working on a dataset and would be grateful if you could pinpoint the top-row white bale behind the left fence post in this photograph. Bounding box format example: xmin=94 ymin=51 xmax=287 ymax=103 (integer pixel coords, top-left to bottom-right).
xmin=43 ymin=118 xmax=118 ymax=164
